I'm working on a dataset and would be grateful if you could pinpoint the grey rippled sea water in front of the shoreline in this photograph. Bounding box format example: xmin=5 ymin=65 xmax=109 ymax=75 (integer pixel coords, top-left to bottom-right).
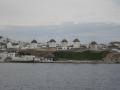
xmin=0 ymin=63 xmax=120 ymax=90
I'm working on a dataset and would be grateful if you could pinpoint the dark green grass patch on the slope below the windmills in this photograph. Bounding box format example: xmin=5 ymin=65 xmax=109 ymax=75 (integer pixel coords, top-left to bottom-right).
xmin=53 ymin=51 xmax=109 ymax=60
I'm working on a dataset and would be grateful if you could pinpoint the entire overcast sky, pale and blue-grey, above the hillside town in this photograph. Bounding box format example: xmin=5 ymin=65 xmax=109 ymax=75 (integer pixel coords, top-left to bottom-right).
xmin=0 ymin=0 xmax=120 ymax=43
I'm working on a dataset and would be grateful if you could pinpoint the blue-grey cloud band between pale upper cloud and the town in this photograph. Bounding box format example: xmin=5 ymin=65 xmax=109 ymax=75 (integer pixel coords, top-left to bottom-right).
xmin=0 ymin=23 xmax=120 ymax=43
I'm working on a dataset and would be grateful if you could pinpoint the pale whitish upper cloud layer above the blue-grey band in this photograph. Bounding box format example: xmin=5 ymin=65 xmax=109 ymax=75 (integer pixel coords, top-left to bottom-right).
xmin=0 ymin=0 xmax=120 ymax=26
